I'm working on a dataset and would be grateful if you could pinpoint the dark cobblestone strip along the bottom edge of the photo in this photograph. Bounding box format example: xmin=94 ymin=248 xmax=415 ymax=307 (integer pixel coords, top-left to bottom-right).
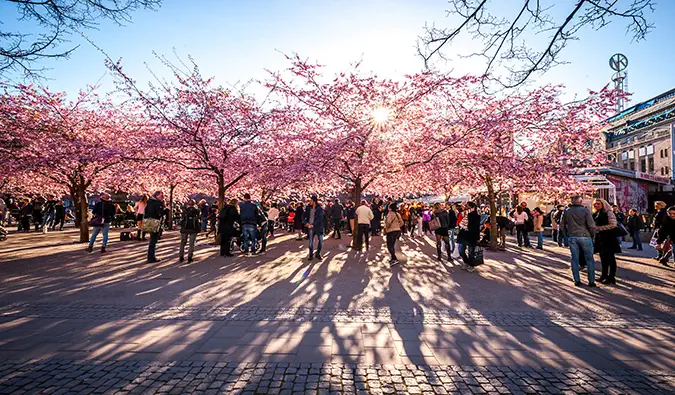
xmin=0 ymin=360 xmax=675 ymax=394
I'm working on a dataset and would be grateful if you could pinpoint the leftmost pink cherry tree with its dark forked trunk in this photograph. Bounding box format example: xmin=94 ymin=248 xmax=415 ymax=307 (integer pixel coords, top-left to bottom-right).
xmin=0 ymin=85 xmax=142 ymax=242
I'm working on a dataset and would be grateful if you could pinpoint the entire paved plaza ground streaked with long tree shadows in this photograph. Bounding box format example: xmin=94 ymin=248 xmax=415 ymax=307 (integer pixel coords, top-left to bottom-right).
xmin=0 ymin=231 xmax=675 ymax=394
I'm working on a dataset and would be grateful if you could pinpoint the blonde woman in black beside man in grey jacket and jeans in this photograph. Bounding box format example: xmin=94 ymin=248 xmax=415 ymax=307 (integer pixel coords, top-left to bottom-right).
xmin=593 ymin=199 xmax=621 ymax=285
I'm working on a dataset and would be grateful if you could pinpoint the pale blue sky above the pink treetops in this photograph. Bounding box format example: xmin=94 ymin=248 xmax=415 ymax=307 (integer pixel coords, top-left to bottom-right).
xmin=0 ymin=0 xmax=675 ymax=102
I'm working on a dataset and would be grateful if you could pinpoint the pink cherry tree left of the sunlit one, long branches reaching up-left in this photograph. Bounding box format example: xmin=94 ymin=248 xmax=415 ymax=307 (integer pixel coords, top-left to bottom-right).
xmin=107 ymin=58 xmax=288 ymax=213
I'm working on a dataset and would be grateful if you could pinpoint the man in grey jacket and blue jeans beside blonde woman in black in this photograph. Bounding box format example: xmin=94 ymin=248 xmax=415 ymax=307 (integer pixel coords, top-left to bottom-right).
xmin=560 ymin=196 xmax=596 ymax=287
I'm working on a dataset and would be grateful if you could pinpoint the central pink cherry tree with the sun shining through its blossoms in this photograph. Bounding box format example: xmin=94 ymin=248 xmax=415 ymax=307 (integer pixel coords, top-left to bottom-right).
xmin=268 ymin=55 xmax=474 ymax=246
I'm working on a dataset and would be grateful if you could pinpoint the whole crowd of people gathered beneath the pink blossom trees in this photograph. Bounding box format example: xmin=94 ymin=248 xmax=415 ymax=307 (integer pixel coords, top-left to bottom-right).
xmin=0 ymin=191 xmax=675 ymax=287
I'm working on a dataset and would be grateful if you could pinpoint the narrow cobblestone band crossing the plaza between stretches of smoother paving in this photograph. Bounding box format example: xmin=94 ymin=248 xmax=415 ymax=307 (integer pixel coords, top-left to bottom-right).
xmin=0 ymin=303 xmax=675 ymax=328
